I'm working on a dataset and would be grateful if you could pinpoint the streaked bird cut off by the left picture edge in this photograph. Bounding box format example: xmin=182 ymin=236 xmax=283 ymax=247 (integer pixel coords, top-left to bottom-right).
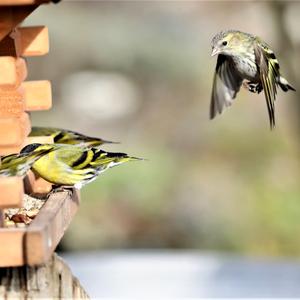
xmin=0 ymin=147 xmax=52 ymax=177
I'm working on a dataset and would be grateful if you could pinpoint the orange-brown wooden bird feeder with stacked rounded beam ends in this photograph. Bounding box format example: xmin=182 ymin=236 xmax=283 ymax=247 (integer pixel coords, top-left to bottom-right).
xmin=0 ymin=0 xmax=86 ymax=298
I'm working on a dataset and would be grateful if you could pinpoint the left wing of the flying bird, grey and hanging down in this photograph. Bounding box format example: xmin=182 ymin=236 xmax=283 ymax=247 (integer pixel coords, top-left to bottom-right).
xmin=210 ymin=54 xmax=243 ymax=119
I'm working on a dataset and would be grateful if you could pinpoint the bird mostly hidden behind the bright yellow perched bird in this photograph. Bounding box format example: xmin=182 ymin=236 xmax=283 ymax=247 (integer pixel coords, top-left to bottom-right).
xmin=29 ymin=126 xmax=116 ymax=147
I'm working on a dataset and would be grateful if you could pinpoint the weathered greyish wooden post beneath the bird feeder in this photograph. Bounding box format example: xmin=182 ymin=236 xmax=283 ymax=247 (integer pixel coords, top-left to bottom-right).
xmin=0 ymin=253 xmax=89 ymax=299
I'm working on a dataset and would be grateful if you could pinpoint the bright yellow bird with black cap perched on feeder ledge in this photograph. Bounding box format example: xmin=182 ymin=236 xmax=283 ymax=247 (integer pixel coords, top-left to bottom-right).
xmin=21 ymin=144 xmax=140 ymax=189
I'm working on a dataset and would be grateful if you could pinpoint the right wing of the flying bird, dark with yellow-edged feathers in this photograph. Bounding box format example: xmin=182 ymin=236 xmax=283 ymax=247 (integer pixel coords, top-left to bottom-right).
xmin=254 ymin=43 xmax=280 ymax=129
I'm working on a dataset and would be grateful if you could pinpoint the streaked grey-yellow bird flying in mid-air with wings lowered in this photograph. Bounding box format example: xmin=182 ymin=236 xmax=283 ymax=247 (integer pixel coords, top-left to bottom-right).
xmin=210 ymin=30 xmax=295 ymax=129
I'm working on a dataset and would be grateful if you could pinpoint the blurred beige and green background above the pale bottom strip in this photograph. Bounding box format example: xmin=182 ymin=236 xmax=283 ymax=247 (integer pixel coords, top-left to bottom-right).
xmin=27 ymin=1 xmax=300 ymax=255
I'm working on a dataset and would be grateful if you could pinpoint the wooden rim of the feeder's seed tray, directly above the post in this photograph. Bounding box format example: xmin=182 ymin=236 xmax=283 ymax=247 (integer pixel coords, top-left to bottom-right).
xmin=0 ymin=190 xmax=79 ymax=268
